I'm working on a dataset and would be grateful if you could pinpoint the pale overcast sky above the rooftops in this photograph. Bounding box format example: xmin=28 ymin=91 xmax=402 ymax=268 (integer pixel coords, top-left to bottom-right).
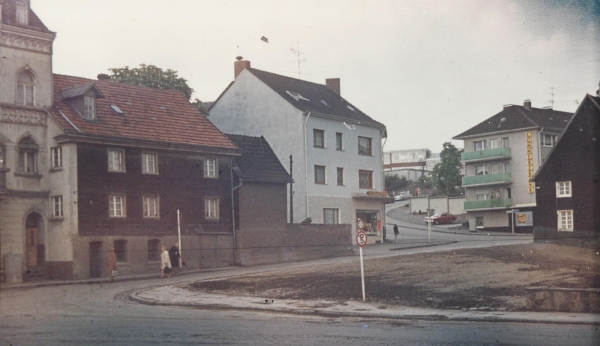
xmin=31 ymin=0 xmax=600 ymax=152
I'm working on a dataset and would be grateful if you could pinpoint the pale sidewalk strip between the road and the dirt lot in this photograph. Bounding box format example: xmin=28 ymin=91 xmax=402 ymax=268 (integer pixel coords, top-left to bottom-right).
xmin=129 ymin=285 xmax=600 ymax=325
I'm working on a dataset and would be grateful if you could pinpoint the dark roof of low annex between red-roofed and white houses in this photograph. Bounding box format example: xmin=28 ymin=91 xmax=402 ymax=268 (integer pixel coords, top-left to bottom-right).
xmin=227 ymin=134 xmax=293 ymax=184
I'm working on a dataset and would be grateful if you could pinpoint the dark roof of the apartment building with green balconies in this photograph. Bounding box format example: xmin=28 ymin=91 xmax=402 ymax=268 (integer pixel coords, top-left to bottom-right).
xmin=453 ymin=105 xmax=573 ymax=139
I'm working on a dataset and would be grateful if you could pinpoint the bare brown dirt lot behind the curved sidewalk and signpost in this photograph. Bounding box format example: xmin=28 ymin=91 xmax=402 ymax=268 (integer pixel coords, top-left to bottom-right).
xmin=190 ymin=244 xmax=600 ymax=311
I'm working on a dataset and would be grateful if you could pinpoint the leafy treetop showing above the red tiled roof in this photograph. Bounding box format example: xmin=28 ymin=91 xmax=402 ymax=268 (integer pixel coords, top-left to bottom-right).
xmin=108 ymin=64 xmax=193 ymax=100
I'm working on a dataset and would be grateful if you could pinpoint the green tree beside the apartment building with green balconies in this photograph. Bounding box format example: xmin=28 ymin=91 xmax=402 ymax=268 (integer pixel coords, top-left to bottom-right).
xmin=431 ymin=142 xmax=461 ymax=196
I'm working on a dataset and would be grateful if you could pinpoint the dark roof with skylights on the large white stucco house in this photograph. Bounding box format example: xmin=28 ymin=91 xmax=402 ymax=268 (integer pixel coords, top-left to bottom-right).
xmin=234 ymin=67 xmax=385 ymax=128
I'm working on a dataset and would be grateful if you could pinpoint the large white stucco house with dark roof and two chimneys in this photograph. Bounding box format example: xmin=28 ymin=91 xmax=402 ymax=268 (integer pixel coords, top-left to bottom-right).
xmin=209 ymin=58 xmax=390 ymax=243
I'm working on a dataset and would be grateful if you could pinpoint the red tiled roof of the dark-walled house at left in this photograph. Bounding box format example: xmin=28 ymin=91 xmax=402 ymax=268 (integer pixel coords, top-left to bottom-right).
xmin=50 ymin=74 xmax=236 ymax=150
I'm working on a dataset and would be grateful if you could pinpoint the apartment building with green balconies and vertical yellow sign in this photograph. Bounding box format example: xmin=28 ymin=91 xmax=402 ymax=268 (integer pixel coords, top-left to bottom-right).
xmin=454 ymin=101 xmax=573 ymax=232
